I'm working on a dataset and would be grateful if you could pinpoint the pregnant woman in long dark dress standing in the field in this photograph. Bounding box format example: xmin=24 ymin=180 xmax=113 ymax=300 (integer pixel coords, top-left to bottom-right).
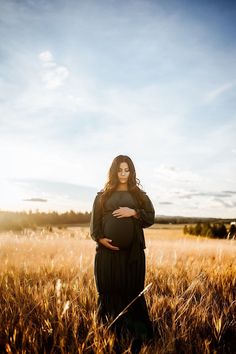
xmin=90 ymin=155 xmax=155 ymax=352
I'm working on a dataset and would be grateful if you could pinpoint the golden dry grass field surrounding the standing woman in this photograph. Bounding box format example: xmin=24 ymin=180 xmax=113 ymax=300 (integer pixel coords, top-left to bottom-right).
xmin=0 ymin=225 xmax=236 ymax=354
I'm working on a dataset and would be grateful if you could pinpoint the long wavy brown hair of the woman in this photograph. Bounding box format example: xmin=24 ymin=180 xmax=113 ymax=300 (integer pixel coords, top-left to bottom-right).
xmin=101 ymin=155 xmax=148 ymax=208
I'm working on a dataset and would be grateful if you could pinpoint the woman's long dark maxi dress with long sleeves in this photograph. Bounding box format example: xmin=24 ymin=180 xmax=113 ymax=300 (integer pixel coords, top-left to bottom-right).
xmin=90 ymin=191 xmax=155 ymax=340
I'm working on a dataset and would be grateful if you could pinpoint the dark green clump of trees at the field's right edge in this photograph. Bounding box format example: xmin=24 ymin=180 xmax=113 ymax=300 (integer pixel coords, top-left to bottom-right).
xmin=183 ymin=223 xmax=236 ymax=238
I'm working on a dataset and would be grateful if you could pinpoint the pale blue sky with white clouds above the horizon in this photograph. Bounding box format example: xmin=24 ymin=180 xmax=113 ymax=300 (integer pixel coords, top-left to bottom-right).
xmin=0 ymin=0 xmax=236 ymax=218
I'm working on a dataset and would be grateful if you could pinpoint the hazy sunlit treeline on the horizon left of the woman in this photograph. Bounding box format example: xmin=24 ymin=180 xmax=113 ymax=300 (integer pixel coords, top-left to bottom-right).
xmin=0 ymin=210 xmax=91 ymax=231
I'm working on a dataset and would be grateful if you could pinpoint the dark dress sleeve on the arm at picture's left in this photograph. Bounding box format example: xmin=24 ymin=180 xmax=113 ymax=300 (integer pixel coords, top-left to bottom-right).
xmin=90 ymin=193 xmax=103 ymax=241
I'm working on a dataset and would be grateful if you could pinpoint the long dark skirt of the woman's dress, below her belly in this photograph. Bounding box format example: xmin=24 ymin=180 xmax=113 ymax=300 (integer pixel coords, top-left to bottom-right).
xmin=94 ymin=247 xmax=152 ymax=340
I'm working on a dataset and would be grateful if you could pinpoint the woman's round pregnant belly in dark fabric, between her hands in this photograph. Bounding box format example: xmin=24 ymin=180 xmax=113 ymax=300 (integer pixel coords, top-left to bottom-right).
xmin=103 ymin=215 xmax=134 ymax=249
